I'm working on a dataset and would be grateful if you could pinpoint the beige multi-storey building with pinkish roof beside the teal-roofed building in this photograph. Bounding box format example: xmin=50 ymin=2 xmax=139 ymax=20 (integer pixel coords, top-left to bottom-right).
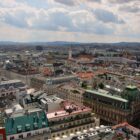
xmin=47 ymin=101 xmax=100 ymax=140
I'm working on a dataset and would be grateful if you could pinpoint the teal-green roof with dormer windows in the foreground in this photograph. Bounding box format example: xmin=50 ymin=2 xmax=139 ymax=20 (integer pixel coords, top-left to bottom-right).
xmin=5 ymin=111 xmax=48 ymax=135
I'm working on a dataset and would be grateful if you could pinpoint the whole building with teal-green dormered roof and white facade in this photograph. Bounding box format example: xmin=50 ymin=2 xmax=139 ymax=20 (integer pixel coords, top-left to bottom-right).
xmin=5 ymin=110 xmax=50 ymax=140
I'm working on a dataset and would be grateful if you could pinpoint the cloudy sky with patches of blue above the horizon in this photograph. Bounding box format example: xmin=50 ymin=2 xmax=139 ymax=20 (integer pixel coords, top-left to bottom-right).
xmin=0 ymin=0 xmax=140 ymax=42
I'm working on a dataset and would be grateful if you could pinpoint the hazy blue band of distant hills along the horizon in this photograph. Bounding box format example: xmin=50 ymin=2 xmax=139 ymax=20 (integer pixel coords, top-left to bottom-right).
xmin=0 ymin=41 xmax=140 ymax=50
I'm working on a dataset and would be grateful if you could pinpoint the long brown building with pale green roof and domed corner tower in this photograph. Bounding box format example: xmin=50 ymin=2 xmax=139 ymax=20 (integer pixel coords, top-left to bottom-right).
xmin=84 ymin=87 xmax=140 ymax=124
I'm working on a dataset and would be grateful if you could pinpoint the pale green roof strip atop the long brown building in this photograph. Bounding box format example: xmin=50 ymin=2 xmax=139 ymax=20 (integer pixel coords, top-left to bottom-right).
xmin=86 ymin=90 xmax=128 ymax=103
